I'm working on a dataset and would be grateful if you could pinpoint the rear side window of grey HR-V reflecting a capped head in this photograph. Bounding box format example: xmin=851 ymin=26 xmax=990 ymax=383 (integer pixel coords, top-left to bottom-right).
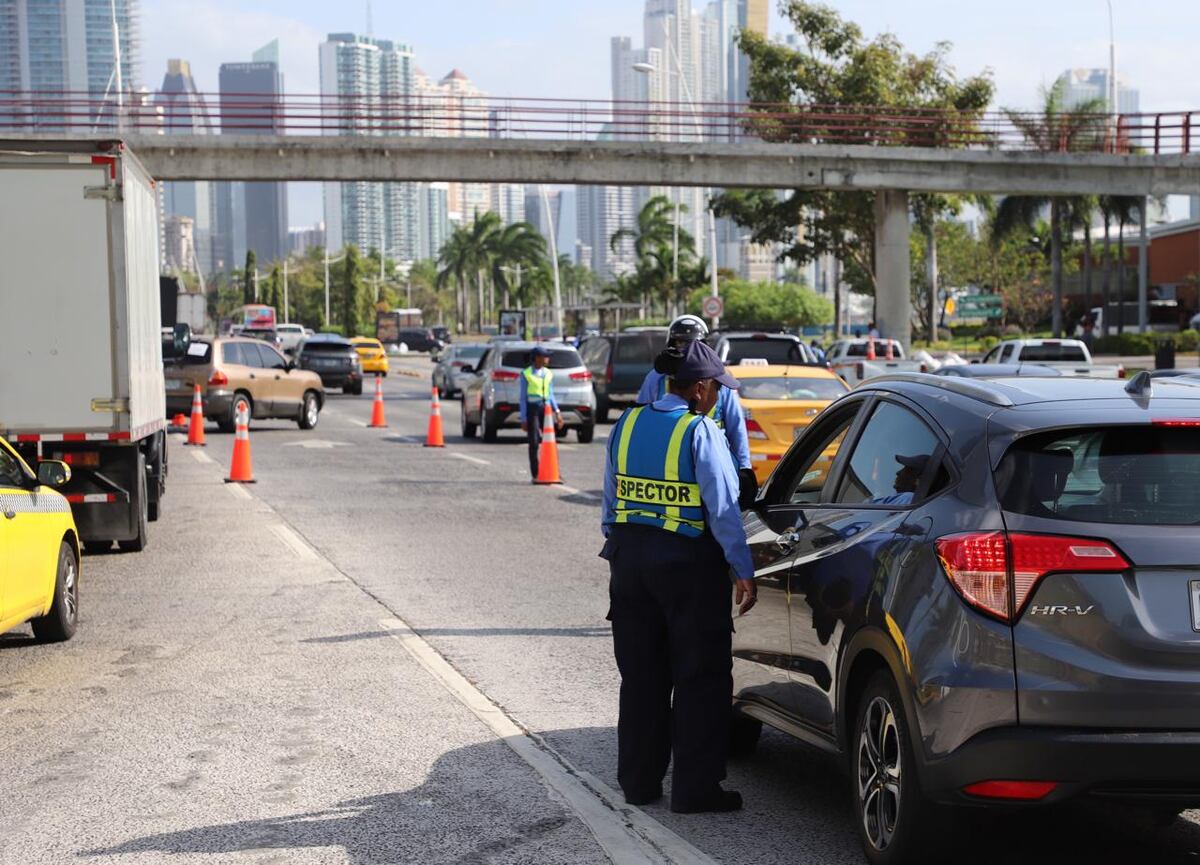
xmin=835 ymin=402 xmax=944 ymax=507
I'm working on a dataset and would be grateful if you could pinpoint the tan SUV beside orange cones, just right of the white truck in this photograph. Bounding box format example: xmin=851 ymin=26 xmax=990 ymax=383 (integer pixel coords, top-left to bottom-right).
xmin=164 ymin=337 xmax=325 ymax=432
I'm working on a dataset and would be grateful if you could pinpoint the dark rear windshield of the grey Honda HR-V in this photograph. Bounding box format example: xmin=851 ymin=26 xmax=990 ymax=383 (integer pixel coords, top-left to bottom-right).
xmin=996 ymin=426 xmax=1200 ymax=525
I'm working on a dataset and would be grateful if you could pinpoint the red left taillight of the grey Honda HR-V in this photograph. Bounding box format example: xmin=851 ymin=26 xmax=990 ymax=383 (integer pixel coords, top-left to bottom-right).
xmin=937 ymin=531 xmax=1130 ymax=623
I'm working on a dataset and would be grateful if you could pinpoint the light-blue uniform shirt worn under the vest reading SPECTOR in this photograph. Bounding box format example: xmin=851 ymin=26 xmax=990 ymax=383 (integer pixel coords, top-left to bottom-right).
xmin=600 ymin=394 xmax=754 ymax=579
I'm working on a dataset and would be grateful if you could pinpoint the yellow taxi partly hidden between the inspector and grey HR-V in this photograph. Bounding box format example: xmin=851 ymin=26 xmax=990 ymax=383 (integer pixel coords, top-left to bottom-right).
xmin=730 ymin=359 xmax=850 ymax=483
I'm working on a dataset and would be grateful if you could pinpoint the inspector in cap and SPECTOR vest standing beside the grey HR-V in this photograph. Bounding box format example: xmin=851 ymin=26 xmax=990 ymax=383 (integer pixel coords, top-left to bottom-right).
xmin=601 ymin=341 xmax=756 ymax=813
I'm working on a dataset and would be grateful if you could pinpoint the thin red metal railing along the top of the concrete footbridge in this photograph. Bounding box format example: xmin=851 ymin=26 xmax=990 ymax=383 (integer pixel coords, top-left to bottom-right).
xmin=0 ymin=91 xmax=1200 ymax=155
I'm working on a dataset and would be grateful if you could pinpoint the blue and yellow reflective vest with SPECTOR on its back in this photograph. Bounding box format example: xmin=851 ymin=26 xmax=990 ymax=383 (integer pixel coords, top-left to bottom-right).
xmin=612 ymin=406 xmax=704 ymax=537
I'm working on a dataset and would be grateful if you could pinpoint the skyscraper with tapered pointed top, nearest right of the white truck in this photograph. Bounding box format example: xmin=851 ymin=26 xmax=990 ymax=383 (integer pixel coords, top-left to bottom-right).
xmin=154 ymin=60 xmax=215 ymax=274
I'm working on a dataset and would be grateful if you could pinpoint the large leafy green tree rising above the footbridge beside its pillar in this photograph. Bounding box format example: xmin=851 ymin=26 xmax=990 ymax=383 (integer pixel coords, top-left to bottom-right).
xmin=714 ymin=0 xmax=994 ymax=316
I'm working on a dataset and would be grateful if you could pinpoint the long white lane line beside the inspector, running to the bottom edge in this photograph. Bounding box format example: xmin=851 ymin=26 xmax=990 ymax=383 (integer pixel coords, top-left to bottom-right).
xmin=379 ymin=618 xmax=716 ymax=865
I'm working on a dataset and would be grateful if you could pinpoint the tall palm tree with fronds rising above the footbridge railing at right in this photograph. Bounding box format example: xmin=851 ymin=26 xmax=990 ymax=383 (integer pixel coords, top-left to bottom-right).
xmin=996 ymin=82 xmax=1108 ymax=337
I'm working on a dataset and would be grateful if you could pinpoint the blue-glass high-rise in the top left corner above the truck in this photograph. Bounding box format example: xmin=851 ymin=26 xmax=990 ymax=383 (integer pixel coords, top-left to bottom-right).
xmin=0 ymin=0 xmax=140 ymax=130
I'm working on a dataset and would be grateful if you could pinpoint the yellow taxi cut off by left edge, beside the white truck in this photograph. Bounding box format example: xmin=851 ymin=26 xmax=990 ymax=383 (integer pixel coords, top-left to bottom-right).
xmin=0 ymin=439 xmax=79 ymax=643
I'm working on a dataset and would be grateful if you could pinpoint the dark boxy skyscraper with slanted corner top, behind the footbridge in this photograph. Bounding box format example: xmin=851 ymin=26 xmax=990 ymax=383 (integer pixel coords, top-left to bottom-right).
xmin=214 ymin=46 xmax=288 ymax=269
